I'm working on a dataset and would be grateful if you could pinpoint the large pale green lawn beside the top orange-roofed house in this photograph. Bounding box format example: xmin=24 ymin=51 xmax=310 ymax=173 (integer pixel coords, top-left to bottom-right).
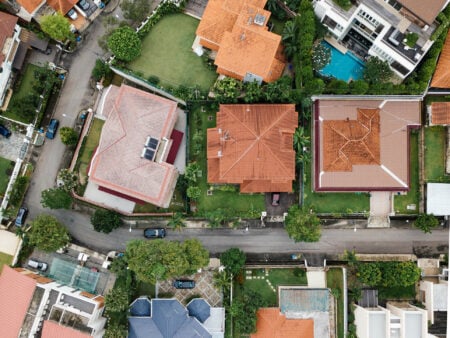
xmin=128 ymin=14 xmax=218 ymax=91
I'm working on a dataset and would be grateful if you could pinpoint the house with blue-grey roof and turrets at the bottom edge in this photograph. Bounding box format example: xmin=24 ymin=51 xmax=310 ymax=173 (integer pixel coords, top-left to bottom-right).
xmin=128 ymin=296 xmax=225 ymax=338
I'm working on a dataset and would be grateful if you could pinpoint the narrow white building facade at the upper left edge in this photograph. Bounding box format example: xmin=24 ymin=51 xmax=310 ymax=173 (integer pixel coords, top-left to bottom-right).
xmin=0 ymin=25 xmax=21 ymax=107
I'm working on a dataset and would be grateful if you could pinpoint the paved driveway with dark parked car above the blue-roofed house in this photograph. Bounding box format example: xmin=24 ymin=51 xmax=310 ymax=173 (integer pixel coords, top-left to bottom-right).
xmin=158 ymin=270 xmax=222 ymax=307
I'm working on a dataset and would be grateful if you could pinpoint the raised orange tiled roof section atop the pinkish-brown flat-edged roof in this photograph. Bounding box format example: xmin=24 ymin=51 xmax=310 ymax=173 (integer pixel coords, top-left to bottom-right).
xmin=323 ymin=108 xmax=380 ymax=171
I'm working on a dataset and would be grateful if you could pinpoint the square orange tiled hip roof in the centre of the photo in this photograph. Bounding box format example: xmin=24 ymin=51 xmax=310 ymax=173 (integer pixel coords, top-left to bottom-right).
xmin=207 ymin=104 xmax=298 ymax=193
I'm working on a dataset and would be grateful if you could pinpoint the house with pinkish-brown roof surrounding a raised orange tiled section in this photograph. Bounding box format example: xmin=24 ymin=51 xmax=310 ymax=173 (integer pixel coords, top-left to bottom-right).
xmin=313 ymin=96 xmax=421 ymax=192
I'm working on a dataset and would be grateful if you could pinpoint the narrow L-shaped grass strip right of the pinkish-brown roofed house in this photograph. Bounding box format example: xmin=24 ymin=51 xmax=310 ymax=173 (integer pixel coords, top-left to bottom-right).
xmin=394 ymin=132 xmax=420 ymax=214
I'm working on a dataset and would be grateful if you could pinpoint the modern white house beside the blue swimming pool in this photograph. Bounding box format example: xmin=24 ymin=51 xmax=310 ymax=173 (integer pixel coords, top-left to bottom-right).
xmin=314 ymin=0 xmax=449 ymax=79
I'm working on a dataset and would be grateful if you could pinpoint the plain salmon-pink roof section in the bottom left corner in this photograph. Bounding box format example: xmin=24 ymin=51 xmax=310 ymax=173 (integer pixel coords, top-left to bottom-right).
xmin=0 ymin=265 xmax=36 ymax=337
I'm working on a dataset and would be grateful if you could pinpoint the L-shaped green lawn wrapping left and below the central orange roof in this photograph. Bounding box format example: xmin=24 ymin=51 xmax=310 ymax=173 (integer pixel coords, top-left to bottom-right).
xmin=189 ymin=104 xmax=265 ymax=217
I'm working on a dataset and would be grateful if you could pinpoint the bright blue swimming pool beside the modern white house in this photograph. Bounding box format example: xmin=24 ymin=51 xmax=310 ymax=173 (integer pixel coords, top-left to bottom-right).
xmin=319 ymin=41 xmax=364 ymax=82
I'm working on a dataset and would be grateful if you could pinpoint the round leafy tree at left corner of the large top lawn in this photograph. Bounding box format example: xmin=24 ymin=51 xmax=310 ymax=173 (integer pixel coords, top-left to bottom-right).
xmin=107 ymin=26 xmax=142 ymax=62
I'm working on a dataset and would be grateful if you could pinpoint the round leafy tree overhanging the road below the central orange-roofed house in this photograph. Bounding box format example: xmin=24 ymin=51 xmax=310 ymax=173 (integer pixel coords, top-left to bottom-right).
xmin=285 ymin=205 xmax=321 ymax=242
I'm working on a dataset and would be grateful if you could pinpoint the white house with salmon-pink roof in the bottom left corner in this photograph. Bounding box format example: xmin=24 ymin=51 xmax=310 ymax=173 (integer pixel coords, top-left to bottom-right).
xmin=0 ymin=265 xmax=106 ymax=338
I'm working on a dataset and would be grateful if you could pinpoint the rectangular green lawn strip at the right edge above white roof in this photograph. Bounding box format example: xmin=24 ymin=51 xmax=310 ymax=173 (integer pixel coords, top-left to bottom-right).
xmin=425 ymin=126 xmax=450 ymax=183
